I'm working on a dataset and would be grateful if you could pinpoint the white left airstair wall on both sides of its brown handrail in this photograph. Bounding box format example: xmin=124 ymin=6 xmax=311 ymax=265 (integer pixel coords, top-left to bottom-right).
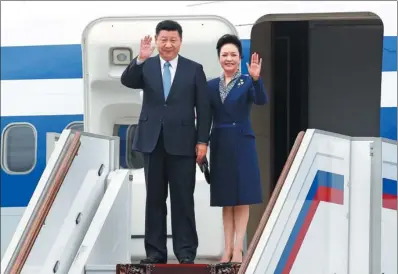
xmin=2 ymin=130 xmax=119 ymax=274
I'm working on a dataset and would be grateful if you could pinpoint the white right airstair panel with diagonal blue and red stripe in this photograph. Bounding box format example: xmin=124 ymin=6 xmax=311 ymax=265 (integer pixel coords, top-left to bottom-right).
xmin=247 ymin=130 xmax=350 ymax=273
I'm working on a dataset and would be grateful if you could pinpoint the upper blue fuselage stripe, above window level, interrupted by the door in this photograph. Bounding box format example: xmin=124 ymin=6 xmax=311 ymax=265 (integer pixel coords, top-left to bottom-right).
xmin=1 ymin=36 xmax=397 ymax=80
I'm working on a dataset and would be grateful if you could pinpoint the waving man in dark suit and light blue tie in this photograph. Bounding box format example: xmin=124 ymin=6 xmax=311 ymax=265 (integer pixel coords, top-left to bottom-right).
xmin=121 ymin=20 xmax=211 ymax=264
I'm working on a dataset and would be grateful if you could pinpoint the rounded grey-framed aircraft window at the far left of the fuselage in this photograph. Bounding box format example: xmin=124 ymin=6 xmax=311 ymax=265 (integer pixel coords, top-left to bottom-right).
xmin=1 ymin=123 xmax=37 ymax=173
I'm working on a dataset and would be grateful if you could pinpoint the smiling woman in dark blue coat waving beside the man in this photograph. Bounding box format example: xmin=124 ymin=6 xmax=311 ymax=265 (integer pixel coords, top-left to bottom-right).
xmin=208 ymin=34 xmax=267 ymax=263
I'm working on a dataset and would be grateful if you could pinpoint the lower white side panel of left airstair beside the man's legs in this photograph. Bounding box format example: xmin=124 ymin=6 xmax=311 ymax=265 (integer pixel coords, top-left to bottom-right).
xmin=68 ymin=169 xmax=133 ymax=274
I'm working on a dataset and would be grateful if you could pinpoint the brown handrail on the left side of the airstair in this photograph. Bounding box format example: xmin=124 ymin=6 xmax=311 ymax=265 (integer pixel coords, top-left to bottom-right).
xmin=5 ymin=131 xmax=81 ymax=274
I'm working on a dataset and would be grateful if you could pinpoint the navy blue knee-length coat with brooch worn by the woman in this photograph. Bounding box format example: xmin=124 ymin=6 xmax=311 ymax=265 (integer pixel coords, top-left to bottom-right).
xmin=208 ymin=75 xmax=267 ymax=206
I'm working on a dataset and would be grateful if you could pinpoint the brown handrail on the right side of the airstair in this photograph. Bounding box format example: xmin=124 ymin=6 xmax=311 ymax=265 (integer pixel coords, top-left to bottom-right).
xmin=238 ymin=131 xmax=305 ymax=274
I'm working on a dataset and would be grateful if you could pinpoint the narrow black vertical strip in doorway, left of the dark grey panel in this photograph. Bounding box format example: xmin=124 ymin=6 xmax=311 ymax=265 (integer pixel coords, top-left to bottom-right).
xmin=271 ymin=21 xmax=308 ymax=187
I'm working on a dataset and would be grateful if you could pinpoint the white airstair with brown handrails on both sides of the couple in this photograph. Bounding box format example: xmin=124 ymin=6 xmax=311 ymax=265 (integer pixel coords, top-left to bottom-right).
xmin=1 ymin=129 xmax=397 ymax=274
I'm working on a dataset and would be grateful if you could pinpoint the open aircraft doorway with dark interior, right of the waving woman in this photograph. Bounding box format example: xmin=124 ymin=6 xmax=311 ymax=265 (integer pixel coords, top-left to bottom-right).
xmin=243 ymin=12 xmax=383 ymax=274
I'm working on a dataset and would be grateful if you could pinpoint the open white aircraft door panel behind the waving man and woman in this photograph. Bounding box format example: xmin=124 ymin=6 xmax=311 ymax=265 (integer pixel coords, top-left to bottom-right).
xmin=82 ymin=16 xmax=237 ymax=259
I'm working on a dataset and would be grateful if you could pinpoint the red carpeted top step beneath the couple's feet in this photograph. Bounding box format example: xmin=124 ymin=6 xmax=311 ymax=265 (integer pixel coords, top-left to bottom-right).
xmin=116 ymin=264 xmax=240 ymax=274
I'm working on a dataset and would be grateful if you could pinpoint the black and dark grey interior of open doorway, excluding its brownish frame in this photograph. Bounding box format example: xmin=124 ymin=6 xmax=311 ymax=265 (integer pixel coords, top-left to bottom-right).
xmin=270 ymin=20 xmax=383 ymax=186
